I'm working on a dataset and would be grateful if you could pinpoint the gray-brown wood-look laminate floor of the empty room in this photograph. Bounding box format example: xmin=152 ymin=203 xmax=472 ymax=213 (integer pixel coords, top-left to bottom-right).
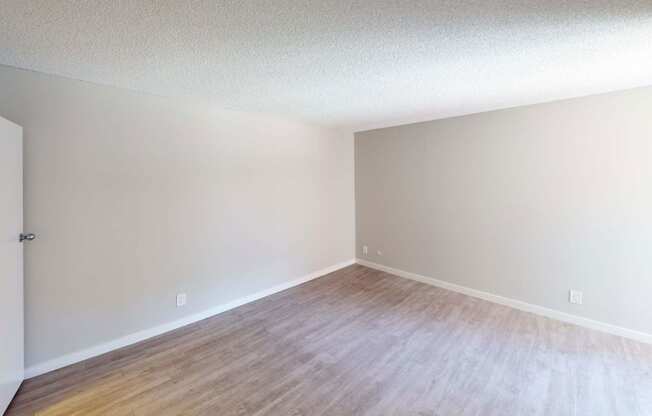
xmin=8 ymin=265 xmax=652 ymax=416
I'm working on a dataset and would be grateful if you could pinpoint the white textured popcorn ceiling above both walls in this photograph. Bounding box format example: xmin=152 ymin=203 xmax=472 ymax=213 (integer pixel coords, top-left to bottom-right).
xmin=0 ymin=0 xmax=652 ymax=130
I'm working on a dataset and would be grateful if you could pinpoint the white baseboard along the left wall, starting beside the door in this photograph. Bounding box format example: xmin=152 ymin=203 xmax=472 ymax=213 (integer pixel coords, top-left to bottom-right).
xmin=25 ymin=259 xmax=356 ymax=379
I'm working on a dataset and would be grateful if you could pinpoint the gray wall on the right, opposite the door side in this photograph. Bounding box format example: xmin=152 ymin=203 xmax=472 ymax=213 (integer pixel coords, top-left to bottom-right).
xmin=355 ymin=88 xmax=652 ymax=333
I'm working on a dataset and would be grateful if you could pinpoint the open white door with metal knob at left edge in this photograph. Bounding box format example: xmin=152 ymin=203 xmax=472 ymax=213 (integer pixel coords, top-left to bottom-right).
xmin=0 ymin=117 xmax=24 ymax=414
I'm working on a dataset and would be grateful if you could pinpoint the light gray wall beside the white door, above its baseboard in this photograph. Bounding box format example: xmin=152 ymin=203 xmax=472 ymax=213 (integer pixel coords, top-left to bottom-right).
xmin=0 ymin=67 xmax=355 ymax=366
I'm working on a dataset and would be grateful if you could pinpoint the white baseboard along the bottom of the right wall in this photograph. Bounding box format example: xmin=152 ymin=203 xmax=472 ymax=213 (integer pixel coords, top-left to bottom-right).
xmin=356 ymin=259 xmax=652 ymax=344
